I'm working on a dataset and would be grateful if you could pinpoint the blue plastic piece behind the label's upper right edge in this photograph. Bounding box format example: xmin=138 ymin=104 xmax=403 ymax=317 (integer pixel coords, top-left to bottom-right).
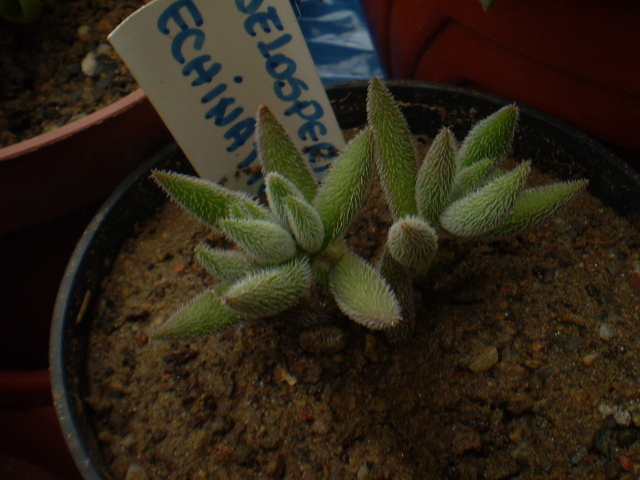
xmin=291 ymin=0 xmax=384 ymax=83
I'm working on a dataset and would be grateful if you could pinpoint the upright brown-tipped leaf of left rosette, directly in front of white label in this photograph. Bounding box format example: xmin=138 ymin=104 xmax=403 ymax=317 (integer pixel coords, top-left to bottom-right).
xmin=256 ymin=105 xmax=317 ymax=202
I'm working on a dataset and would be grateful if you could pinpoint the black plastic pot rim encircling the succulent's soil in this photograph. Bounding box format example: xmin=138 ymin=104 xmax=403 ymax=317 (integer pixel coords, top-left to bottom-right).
xmin=50 ymin=81 xmax=640 ymax=480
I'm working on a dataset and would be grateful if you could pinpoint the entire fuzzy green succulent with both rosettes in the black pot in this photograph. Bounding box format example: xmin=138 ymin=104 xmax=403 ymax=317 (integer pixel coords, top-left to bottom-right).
xmin=152 ymin=78 xmax=586 ymax=341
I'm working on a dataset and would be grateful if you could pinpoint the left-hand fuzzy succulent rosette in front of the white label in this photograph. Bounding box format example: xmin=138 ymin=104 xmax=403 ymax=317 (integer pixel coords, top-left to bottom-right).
xmin=153 ymin=106 xmax=400 ymax=338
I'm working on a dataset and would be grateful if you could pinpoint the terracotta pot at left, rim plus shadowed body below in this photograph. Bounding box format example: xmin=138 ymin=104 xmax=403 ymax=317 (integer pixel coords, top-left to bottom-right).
xmin=0 ymin=90 xmax=171 ymax=370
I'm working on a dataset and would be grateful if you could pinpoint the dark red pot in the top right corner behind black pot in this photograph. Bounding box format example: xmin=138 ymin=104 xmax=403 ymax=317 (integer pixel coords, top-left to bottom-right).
xmin=362 ymin=0 xmax=640 ymax=170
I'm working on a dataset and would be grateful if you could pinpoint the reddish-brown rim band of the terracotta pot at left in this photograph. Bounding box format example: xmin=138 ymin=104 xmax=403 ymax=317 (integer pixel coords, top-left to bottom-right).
xmin=0 ymin=90 xmax=171 ymax=235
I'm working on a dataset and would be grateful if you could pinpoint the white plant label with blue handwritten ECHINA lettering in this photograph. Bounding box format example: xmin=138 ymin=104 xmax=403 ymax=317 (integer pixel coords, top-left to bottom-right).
xmin=109 ymin=0 xmax=344 ymax=192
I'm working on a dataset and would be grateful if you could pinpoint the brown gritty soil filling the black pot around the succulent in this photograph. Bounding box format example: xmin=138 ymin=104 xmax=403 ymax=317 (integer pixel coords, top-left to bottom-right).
xmin=86 ymin=140 xmax=640 ymax=480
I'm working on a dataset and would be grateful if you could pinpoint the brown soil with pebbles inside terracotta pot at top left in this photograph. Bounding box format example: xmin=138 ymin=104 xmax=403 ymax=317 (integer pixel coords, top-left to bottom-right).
xmin=0 ymin=0 xmax=144 ymax=147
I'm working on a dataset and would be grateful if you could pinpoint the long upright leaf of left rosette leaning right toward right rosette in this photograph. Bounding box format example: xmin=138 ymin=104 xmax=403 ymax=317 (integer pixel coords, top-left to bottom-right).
xmin=315 ymin=129 xmax=373 ymax=246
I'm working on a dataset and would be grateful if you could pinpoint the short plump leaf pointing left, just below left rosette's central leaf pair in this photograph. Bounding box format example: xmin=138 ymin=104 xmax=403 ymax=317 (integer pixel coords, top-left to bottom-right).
xmin=218 ymin=219 xmax=296 ymax=264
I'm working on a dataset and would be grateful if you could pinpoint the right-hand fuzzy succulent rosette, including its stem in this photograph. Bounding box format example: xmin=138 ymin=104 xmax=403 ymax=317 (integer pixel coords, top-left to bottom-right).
xmin=367 ymin=78 xmax=587 ymax=339
